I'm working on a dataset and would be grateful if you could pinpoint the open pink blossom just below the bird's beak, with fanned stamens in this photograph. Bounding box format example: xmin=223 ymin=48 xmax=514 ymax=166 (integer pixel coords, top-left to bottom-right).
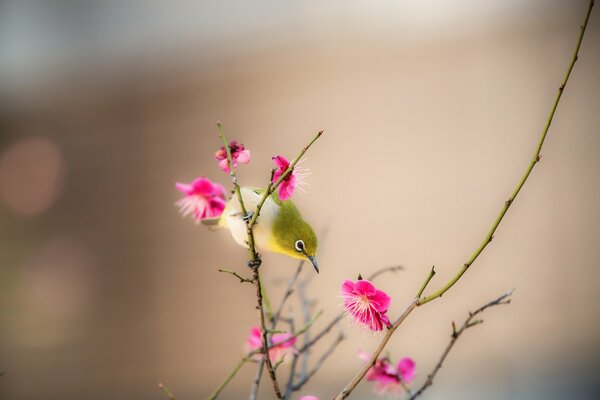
xmin=342 ymin=280 xmax=391 ymax=331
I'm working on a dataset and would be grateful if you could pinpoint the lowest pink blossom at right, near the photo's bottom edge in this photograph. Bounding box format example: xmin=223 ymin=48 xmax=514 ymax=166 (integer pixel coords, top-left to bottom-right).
xmin=358 ymin=352 xmax=415 ymax=396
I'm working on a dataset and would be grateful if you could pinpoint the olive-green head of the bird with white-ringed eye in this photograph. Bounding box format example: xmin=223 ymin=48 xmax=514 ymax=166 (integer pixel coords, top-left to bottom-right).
xmin=271 ymin=200 xmax=319 ymax=273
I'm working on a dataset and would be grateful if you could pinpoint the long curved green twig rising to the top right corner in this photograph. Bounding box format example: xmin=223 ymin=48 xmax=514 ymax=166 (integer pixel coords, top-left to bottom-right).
xmin=419 ymin=0 xmax=594 ymax=305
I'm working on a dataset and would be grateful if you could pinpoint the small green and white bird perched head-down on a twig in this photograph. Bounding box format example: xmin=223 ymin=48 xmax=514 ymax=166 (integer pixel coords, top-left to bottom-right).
xmin=202 ymin=186 xmax=319 ymax=273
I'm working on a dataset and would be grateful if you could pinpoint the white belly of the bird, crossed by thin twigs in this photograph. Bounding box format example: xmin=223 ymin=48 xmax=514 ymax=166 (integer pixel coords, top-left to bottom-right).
xmin=221 ymin=187 xmax=279 ymax=251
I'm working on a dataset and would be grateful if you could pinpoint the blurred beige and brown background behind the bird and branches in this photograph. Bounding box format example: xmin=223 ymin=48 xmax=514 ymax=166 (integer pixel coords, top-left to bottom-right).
xmin=0 ymin=0 xmax=600 ymax=400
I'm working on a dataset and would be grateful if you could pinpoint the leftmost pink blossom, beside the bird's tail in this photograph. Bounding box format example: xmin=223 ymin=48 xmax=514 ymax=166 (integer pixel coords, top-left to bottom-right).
xmin=175 ymin=177 xmax=226 ymax=223
